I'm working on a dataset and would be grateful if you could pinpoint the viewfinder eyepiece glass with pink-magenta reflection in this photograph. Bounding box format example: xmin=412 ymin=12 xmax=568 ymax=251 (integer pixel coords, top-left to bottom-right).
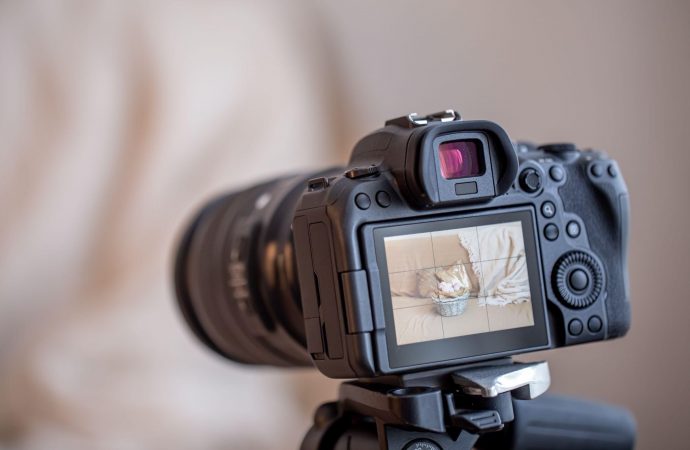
xmin=438 ymin=139 xmax=484 ymax=180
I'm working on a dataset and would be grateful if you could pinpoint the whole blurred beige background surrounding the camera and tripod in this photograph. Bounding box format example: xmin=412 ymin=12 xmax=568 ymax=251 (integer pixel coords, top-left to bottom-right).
xmin=0 ymin=0 xmax=690 ymax=450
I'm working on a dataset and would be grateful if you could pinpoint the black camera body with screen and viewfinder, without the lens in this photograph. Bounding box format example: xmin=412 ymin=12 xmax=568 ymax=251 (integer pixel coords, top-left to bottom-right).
xmin=292 ymin=111 xmax=630 ymax=378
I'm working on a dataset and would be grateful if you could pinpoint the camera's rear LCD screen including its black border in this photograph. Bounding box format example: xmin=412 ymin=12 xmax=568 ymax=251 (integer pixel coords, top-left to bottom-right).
xmin=375 ymin=210 xmax=548 ymax=366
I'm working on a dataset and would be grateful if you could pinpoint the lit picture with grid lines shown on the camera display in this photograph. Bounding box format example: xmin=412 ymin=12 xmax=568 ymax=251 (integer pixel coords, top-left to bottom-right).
xmin=384 ymin=221 xmax=534 ymax=345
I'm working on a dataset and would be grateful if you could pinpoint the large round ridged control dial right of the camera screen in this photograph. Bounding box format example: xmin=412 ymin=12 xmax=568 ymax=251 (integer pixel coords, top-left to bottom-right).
xmin=553 ymin=251 xmax=604 ymax=309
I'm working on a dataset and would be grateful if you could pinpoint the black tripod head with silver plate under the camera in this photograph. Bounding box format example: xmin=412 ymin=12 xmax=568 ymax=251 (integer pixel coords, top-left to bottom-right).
xmin=301 ymin=358 xmax=635 ymax=450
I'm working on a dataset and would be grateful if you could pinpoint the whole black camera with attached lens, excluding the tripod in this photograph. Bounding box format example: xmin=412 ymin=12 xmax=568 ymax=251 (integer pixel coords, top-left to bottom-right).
xmin=175 ymin=110 xmax=630 ymax=379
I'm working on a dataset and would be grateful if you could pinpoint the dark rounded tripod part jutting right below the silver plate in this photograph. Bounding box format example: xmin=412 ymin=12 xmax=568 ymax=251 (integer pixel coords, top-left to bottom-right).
xmin=477 ymin=395 xmax=636 ymax=450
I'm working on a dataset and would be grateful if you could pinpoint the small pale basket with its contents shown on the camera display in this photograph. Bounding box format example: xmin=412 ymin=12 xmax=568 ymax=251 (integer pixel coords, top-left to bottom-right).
xmin=431 ymin=265 xmax=471 ymax=317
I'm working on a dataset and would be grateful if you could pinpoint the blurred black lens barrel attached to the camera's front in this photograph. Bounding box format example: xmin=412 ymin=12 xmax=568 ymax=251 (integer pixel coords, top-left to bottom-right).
xmin=174 ymin=176 xmax=311 ymax=366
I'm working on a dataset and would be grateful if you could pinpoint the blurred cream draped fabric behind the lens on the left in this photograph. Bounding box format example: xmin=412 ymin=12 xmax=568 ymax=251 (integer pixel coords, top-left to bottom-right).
xmin=0 ymin=1 xmax=335 ymax=449
